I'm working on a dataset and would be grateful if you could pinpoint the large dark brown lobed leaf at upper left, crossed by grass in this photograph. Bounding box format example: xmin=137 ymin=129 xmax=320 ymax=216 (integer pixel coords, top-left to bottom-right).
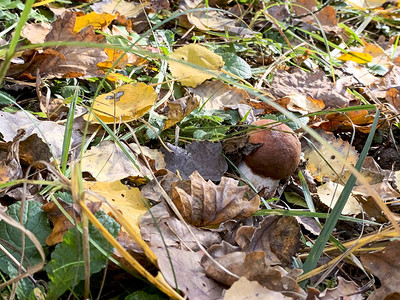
xmin=8 ymin=11 xmax=107 ymax=79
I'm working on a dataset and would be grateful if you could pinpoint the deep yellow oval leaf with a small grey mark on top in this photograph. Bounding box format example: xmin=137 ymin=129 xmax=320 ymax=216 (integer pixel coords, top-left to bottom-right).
xmin=84 ymin=82 xmax=157 ymax=124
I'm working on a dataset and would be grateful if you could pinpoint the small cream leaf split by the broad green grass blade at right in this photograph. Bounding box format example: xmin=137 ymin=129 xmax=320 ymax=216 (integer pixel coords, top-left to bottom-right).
xmin=317 ymin=181 xmax=362 ymax=215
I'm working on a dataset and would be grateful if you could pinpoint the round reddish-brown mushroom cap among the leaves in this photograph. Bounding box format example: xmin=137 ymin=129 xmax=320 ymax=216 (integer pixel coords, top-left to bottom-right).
xmin=245 ymin=119 xmax=301 ymax=179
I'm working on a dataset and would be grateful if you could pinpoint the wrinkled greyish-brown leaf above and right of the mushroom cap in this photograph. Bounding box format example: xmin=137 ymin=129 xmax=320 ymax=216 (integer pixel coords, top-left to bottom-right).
xmin=267 ymin=68 xmax=352 ymax=108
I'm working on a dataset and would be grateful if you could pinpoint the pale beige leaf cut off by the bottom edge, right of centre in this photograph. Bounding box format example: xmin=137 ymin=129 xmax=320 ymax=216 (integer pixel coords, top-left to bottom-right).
xmin=223 ymin=277 xmax=293 ymax=300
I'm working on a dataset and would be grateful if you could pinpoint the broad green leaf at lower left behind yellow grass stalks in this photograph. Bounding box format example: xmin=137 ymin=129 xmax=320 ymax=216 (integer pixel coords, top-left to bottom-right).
xmin=46 ymin=211 xmax=119 ymax=299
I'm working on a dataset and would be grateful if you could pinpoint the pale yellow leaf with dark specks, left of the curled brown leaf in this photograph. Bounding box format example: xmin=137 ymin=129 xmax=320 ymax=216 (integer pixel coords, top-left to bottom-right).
xmin=85 ymin=181 xmax=147 ymax=232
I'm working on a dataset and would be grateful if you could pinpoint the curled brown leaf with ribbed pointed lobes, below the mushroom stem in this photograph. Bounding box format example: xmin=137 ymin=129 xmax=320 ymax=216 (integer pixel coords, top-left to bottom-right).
xmin=172 ymin=171 xmax=260 ymax=226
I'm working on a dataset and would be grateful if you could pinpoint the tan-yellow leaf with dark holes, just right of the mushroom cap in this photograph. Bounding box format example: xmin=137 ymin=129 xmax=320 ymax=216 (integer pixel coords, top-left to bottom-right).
xmin=304 ymin=131 xmax=358 ymax=182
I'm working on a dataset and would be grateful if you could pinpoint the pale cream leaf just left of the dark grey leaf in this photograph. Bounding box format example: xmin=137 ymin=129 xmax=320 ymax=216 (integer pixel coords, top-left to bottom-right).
xmin=82 ymin=141 xmax=165 ymax=182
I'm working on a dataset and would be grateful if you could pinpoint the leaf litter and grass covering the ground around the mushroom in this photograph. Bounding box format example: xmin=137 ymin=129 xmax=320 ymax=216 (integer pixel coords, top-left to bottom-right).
xmin=0 ymin=0 xmax=400 ymax=299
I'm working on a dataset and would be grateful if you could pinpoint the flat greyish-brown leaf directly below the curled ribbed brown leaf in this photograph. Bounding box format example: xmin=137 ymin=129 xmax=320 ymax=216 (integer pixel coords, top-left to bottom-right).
xmin=140 ymin=202 xmax=221 ymax=251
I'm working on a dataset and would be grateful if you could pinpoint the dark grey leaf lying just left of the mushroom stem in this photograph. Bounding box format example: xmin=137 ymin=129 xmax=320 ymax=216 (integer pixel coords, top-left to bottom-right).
xmin=161 ymin=141 xmax=228 ymax=181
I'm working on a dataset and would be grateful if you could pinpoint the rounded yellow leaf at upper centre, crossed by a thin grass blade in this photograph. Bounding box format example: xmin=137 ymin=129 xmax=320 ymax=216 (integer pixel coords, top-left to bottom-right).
xmin=168 ymin=44 xmax=224 ymax=87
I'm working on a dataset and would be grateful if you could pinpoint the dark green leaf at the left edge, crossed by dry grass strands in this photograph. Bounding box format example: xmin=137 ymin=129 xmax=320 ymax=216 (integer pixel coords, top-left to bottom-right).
xmin=0 ymin=201 xmax=51 ymax=299
